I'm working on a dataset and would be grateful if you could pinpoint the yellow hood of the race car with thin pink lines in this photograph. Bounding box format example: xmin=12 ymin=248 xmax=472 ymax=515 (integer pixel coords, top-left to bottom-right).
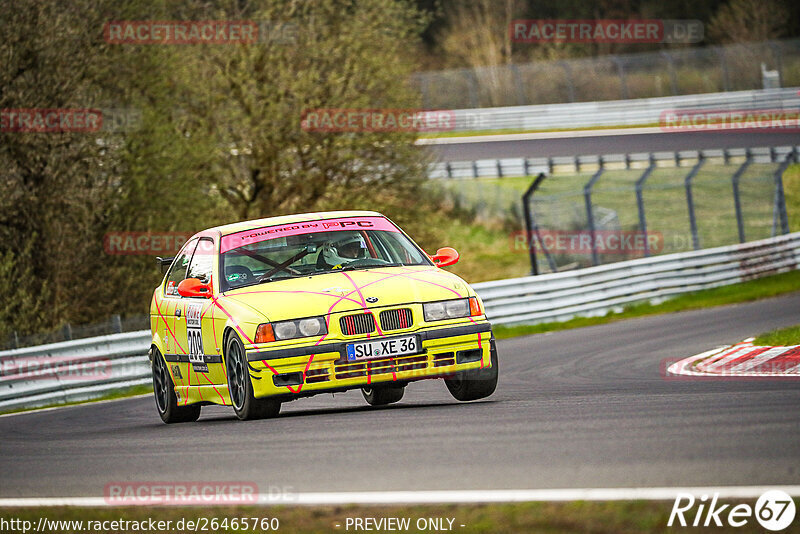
xmin=223 ymin=266 xmax=474 ymax=322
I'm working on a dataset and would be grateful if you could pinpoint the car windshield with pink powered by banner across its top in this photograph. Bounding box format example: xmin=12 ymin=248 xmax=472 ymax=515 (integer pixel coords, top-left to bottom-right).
xmin=221 ymin=218 xmax=431 ymax=291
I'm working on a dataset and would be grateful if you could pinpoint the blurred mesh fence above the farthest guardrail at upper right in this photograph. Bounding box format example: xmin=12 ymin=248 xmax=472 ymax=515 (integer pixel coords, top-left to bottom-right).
xmin=413 ymin=39 xmax=800 ymax=109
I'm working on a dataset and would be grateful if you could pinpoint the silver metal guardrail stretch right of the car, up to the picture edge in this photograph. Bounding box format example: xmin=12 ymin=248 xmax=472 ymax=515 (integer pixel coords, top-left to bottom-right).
xmin=472 ymin=232 xmax=800 ymax=324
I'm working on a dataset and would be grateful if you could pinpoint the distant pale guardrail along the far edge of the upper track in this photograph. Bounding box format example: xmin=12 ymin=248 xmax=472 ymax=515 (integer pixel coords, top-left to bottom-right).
xmin=438 ymin=87 xmax=800 ymax=132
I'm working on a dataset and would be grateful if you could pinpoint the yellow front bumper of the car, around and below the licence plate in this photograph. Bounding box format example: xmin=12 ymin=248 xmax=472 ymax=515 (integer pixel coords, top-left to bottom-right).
xmin=247 ymin=321 xmax=494 ymax=398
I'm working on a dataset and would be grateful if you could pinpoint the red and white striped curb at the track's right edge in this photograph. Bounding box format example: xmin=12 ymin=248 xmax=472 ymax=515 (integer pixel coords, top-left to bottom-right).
xmin=667 ymin=338 xmax=800 ymax=379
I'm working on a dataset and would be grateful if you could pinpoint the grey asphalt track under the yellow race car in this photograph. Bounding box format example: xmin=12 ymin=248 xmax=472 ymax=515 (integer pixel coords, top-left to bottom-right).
xmin=0 ymin=293 xmax=800 ymax=497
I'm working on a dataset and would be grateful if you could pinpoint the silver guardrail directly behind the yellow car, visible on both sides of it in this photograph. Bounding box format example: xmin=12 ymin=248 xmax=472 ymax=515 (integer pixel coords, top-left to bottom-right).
xmin=0 ymin=232 xmax=800 ymax=410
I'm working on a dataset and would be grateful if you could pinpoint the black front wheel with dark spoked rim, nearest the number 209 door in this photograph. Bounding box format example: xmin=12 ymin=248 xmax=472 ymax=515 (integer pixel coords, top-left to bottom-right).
xmin=225 ymin=333 xmax=281 ymax=421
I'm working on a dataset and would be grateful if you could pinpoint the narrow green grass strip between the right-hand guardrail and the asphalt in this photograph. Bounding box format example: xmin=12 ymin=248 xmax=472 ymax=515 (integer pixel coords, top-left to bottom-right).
xmin=492 ymin=271 xmax=800 ymax=343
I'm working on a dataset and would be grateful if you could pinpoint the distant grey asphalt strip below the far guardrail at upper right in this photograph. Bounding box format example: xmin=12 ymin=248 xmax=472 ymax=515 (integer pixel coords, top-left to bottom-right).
xmin=430 ymin=131 xmax=800 ymax=161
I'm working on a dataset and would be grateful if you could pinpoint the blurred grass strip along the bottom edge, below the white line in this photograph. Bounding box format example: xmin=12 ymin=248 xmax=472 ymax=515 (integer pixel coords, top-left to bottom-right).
xmin=0 ymin=500 xmax=758 ymax=534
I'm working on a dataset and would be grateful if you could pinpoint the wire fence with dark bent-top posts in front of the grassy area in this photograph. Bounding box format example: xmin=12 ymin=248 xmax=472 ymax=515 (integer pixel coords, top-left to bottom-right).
xmin=523 ymin=148 xmax=798 ymax=273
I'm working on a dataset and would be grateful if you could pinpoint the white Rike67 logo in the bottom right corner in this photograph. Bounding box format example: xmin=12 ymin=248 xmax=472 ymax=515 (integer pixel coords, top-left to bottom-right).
xmin=667 ymin=490 xmax=795 ymax=531
